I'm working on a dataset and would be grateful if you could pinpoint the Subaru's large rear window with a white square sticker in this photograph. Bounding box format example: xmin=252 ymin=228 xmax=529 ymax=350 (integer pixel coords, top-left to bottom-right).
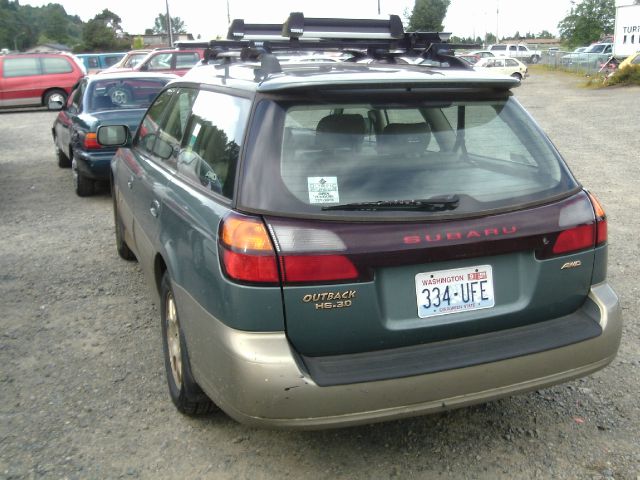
xmin=241 ymin=94 xmax=576 ymax=216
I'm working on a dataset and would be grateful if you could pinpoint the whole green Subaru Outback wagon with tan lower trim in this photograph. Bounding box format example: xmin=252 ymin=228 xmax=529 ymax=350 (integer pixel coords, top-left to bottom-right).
xmin=98 ymin=15 xmax=621 ymax=428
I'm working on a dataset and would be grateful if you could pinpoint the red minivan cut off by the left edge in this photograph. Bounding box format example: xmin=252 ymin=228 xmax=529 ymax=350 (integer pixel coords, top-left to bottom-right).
xmin=0 ymin=53 xmax=86 ymax=108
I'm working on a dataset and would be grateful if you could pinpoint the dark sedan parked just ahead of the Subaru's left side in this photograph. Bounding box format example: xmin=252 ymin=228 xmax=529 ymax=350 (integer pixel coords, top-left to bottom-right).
xmin=49 ymin=72 xmax=178 ymax=197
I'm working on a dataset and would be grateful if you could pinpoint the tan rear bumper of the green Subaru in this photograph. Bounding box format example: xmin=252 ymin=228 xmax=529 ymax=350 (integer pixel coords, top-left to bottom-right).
xmin=175 ymin=283 xmax=622 ymax=429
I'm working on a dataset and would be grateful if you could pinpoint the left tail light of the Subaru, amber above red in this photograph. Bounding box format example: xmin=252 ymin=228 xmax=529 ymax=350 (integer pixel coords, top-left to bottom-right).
xmin=220 ymin=213 xmax=359 ymax=285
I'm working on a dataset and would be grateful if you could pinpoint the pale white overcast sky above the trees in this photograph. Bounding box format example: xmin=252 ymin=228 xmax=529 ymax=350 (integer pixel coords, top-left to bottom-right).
xmin=20 ymin=0 xmax=571 ymax=40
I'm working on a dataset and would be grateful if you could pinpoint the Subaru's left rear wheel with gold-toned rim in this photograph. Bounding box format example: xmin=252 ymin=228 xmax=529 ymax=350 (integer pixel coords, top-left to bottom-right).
xmin=160 ymin=272 xmax=217 ymax=415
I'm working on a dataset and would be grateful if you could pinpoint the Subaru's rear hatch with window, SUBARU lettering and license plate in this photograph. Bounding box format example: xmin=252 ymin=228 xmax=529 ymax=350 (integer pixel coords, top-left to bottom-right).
xmin=238 ymin=85 xmax=606 ymax=357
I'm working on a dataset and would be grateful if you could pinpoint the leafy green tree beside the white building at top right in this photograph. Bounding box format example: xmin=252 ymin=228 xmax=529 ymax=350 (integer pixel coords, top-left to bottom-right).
xmin=558 ymin=0 xmax=616 ymax=48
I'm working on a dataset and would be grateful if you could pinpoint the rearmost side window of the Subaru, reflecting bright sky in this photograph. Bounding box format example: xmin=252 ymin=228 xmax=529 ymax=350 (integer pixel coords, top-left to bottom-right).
xmin=178 ymin=91 xmax=251 ymax=198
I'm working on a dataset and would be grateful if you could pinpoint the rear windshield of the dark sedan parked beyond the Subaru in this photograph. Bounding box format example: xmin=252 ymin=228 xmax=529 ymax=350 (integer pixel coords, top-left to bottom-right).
xmin=87 ymin=77 xmax=168 ymax=111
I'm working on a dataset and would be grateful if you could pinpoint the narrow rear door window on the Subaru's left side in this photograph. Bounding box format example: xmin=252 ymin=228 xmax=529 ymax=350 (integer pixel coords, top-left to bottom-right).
xmin=152 ymin=88 xmax=198 ymax=167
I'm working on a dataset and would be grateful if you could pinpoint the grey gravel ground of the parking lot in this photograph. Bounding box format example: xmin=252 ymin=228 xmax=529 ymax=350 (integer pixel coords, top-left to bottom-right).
xmin=0 ymin=70 xmax=640 ymax=480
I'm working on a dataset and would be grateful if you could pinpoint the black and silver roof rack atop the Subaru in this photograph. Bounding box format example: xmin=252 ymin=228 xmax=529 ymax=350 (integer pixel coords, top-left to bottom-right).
xmin=202 ymin=12 xmax=478 ymax=73
